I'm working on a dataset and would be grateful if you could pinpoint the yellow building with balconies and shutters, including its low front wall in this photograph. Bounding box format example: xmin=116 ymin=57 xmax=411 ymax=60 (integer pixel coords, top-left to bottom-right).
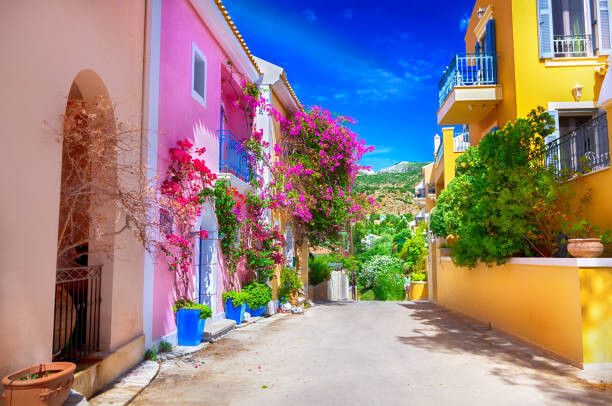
xmin=428 ymin=0 xmax=612 ymax=374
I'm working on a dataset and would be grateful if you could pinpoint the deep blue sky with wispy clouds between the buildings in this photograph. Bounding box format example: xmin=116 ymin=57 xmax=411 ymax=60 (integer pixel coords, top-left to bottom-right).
xmin=224 ymin=0 xmax=474 ymax=170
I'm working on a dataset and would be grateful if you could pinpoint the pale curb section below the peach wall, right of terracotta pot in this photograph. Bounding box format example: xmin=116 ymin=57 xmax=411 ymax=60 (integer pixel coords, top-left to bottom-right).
xmin=88 ymin=361 xmax=159 ymax=406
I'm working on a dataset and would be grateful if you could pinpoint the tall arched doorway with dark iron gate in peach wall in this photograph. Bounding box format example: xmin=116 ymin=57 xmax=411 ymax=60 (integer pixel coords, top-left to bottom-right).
xmin=53 ymin=70 xmax=116 ymax=361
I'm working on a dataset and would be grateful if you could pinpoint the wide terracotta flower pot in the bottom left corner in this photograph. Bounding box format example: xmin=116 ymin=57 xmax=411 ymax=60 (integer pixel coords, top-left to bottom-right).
xmin=2 ymin=362 xmax=76 ymax=406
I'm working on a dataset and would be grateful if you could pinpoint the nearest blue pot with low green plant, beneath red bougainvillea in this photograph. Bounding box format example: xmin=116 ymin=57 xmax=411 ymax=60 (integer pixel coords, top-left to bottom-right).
xmin=172 ymin=299 xmax=212 ymax=346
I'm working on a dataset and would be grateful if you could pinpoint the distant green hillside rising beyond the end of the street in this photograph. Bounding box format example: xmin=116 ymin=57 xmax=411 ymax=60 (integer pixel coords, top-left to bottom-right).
xmin=355 ymin=161 xmax=427 ymax=215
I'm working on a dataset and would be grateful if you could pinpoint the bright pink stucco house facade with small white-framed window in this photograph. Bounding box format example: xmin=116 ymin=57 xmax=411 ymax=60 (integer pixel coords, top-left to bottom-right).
xmin=151 ymin=0 xmax=258 ymax=342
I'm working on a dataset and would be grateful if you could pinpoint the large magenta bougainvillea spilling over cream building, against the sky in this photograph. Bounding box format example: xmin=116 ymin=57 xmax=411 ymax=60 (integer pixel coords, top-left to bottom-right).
xmin=236 ymin=79 xmax=374 ymax=244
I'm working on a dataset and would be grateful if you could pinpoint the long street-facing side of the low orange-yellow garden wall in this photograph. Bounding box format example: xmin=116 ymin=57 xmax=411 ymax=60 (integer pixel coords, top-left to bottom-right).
xmin=437 ymin=260 xmax=582 ymax=365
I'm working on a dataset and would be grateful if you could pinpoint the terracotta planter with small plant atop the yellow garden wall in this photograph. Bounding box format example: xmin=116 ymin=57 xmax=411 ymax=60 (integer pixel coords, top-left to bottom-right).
xmin=567 ymin=218 xmax=610 ymax=258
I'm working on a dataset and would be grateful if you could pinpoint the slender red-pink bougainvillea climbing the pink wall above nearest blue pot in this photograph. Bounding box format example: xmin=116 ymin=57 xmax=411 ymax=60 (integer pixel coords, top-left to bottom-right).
xmin=159 ymin=139 xmax=216 ymax=299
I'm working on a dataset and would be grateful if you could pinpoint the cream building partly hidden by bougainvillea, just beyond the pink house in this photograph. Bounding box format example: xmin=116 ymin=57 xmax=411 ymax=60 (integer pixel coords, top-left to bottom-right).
xmin=256 ymin=58 xmax=308 ymax=299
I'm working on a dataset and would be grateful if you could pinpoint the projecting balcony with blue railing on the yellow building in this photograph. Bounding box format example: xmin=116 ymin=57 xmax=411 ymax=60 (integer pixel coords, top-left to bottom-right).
xmin=438 ymin=52 xmax=502 ymax=125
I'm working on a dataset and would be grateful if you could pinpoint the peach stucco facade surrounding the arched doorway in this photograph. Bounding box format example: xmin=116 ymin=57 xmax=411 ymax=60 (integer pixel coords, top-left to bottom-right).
xmin=0 ymin=0 xmax=146 ymax=390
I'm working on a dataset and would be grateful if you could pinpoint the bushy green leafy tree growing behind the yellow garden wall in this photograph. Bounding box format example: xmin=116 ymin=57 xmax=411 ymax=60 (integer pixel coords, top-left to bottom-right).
xmin=431 ymin=107 xmax=570 ymax=267
